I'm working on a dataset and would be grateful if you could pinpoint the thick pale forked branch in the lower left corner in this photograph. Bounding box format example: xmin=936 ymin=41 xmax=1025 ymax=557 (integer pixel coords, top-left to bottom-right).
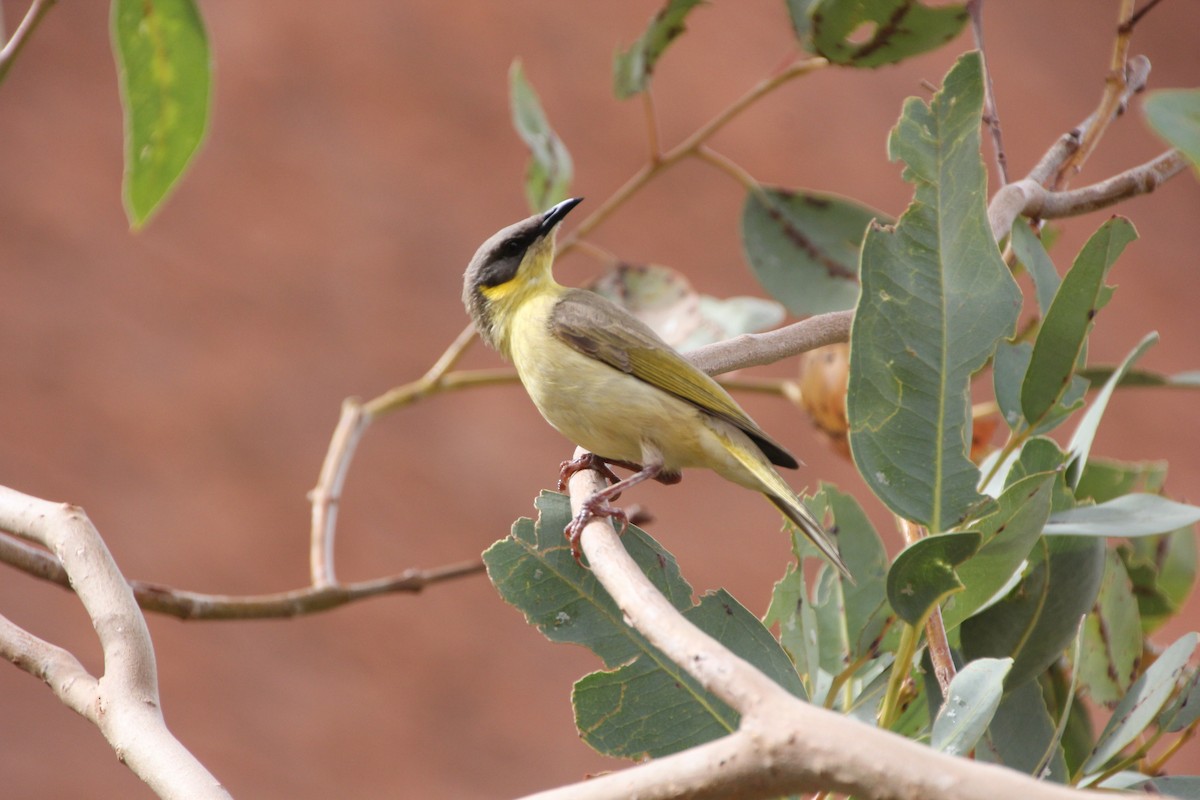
xmin=0 ymin=487 xmax=229 ymax=798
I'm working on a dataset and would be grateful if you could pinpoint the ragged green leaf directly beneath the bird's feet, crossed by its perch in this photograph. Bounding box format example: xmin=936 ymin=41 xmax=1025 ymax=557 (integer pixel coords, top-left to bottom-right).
xmin=484 ymin=492 xmax=691 ymax=667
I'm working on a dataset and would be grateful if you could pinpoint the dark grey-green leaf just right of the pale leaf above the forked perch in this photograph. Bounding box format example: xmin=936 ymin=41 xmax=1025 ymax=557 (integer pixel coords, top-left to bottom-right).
xmin=971 ymin=681 xmax=1067 ymax=782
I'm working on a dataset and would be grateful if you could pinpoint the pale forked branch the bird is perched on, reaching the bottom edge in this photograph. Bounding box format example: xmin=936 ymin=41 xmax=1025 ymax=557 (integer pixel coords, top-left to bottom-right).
xmin=530 ymin=455 xmax=1109 ymax=800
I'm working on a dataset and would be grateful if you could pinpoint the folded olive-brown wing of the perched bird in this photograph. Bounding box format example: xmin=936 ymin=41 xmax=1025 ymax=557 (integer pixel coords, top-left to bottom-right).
xmin=550 ymin=289 xmax=798 ymax=469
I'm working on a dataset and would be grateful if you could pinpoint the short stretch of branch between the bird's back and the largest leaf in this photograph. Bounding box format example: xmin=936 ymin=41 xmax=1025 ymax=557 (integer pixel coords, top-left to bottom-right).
xmin=686 ymin=311 xmax=854 ymax=375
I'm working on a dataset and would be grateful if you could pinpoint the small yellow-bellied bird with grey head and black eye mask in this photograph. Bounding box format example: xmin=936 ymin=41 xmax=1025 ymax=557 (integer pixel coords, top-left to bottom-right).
xmin=462 ymin=197 xmax=850 ymax=576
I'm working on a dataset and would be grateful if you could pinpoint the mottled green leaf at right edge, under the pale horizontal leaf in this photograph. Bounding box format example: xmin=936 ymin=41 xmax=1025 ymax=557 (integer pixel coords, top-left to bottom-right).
xmin=1117 ymin=525 xmax=1196 ymax=633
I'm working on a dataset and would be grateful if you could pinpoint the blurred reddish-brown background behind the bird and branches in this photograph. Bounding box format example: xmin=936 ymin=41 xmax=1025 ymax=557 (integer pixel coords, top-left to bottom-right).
xmin=0 ymin=0 xmax=1200 ymax=799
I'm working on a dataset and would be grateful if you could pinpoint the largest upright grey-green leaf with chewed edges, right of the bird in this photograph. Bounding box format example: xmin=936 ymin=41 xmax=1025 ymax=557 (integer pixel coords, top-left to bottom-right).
xmin=847 ymin=53 xmax=1020 ymax=533
